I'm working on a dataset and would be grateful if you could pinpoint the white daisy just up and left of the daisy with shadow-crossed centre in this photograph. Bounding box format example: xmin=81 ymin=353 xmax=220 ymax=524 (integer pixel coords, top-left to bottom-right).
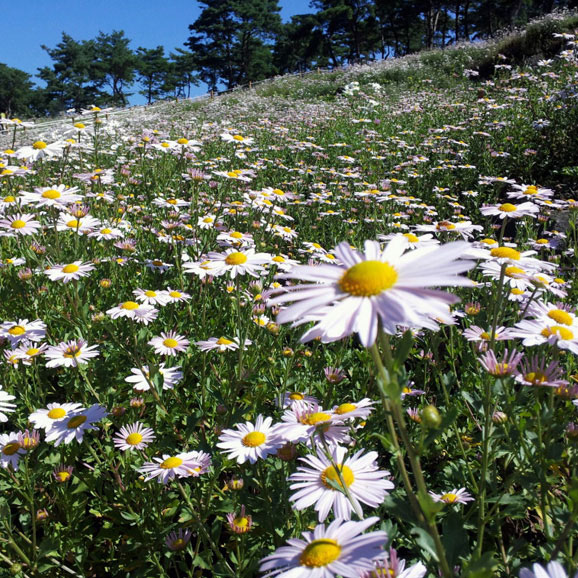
xmin=217 ymin=415 xmax=285 ymax=464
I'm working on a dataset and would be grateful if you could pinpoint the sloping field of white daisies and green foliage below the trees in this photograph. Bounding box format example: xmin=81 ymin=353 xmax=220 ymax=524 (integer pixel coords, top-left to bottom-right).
xmin=0 ymin=20 xmax=578 ymax=578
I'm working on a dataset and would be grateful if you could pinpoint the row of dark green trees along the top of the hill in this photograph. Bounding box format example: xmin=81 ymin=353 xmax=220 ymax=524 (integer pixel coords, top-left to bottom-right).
xmin=0 ymin=0 xmax=578 ymax=116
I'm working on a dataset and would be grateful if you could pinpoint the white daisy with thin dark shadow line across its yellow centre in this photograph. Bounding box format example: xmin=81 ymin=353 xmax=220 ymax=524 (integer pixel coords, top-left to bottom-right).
xmin=289 ymin=446 xmax=394 ymax=522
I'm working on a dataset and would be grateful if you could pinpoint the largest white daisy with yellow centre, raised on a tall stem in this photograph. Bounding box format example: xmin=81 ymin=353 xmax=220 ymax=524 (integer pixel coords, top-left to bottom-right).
xmin=268 ymin=238 xmax=475 ymax=347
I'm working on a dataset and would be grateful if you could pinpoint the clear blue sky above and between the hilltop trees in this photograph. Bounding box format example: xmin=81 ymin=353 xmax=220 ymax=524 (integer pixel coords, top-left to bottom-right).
xmin=0 ymin=0 xmax=311 ymax=102
